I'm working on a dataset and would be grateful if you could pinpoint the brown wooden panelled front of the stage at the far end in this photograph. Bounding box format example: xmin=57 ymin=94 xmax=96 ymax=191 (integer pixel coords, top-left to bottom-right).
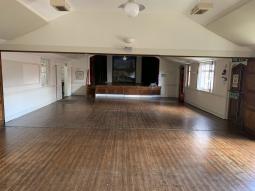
xmin=96 ymin=85 xmax=161 ymax=95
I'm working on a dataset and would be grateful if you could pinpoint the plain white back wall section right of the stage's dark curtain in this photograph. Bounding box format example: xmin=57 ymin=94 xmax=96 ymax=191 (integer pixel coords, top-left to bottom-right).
xmin=159 ymin=58 xmax=180 ymax=98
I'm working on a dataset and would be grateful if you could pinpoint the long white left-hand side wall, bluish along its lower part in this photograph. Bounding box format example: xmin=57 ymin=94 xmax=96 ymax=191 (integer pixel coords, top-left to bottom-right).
xmin=2 ymin=53 xmax=68 ymax=121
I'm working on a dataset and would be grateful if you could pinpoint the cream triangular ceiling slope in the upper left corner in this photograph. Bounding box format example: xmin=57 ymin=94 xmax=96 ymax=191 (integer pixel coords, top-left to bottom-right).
xmin=0 ymin=0 xmax=47 ymax=40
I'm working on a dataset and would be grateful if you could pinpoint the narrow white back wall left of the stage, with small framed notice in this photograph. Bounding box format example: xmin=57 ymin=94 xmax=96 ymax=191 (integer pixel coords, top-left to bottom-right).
xmin=69 ymin=55 xmax=90 ymax=95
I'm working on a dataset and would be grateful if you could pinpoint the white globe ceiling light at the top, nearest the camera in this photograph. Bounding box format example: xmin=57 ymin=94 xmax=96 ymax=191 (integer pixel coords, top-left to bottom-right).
xmin=119 ymin=0 xmax=145 ymax=17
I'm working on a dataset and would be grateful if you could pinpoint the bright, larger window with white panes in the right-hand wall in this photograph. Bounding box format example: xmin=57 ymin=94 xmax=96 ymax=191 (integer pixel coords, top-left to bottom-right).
xmin=197 ymin=61 xmax=215 ymax=92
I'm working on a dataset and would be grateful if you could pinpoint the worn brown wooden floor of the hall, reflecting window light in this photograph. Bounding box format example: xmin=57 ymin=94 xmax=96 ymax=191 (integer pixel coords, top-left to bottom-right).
xmin=0 ymin=98 xmax=255 ymax=191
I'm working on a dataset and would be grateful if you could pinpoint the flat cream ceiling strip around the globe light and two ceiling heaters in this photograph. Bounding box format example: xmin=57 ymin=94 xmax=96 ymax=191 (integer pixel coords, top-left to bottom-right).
xmin=18 ymin=0 xmax=247 ymax=25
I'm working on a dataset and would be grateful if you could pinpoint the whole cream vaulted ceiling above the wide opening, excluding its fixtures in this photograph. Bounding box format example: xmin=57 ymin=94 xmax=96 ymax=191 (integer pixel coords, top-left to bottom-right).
xmin=0 ymin=0 xmax=255 ymax=56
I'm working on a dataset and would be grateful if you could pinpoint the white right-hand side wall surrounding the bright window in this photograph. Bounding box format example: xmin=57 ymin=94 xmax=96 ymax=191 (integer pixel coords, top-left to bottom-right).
xmin=185 ymin=59 xmax=231 ymax=119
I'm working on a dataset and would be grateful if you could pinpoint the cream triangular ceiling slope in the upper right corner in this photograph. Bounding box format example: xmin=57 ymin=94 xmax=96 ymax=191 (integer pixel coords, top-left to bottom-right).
xmin=207 ymin=0 xmax=255 ymax=49
